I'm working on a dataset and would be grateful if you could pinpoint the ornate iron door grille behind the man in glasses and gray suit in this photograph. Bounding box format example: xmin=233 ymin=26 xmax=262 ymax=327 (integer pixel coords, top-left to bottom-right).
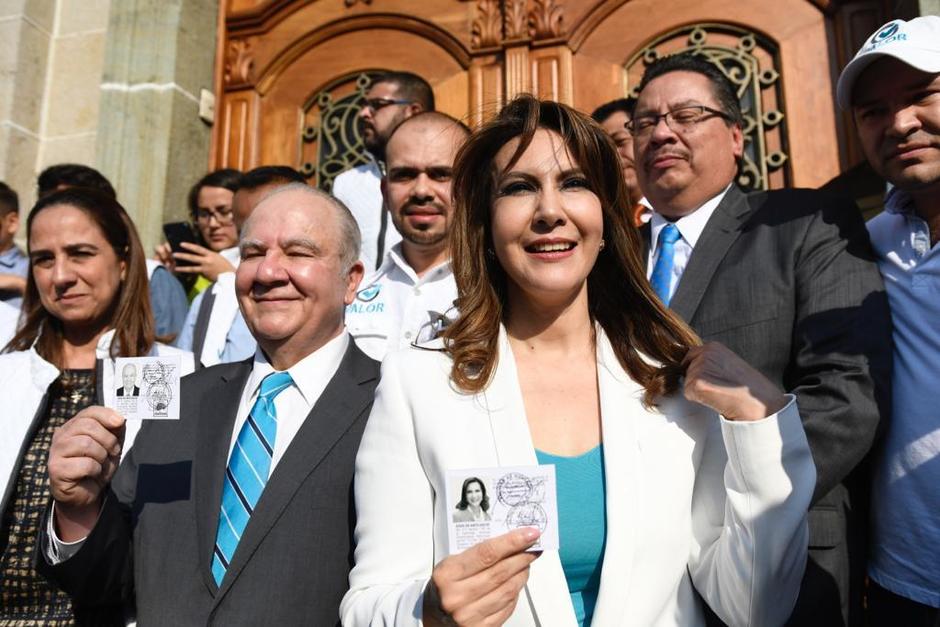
xmin=626 ymin=23 xmax=792 ymax=190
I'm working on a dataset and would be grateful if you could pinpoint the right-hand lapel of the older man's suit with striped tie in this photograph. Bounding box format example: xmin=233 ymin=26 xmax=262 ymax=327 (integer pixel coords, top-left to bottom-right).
xmin=215 ymin=341 xmax=378 ymax=604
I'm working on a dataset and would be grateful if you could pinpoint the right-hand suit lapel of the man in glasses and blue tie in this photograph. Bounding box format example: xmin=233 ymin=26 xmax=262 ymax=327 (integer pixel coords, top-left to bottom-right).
xmin=669 ymin=185 xmax=751 ymax=321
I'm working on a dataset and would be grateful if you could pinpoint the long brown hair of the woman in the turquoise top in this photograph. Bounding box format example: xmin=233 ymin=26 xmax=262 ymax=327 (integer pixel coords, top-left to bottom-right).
xmin=444 ymin=95 xmax=699 ymax=405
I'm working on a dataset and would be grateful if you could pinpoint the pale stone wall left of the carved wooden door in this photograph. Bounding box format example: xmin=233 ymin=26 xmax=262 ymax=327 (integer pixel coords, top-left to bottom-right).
xmin=0 ymin=0 xmax=218 ymax=251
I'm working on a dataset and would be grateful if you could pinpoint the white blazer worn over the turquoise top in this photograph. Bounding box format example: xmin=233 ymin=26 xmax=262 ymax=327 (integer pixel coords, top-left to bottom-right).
xmin=340 ymin=328 xmax=816 ymax=627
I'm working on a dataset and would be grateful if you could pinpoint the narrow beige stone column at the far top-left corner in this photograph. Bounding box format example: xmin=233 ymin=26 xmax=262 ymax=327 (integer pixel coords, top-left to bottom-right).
xmin=0 ymin=0 xmax=55 ymax=215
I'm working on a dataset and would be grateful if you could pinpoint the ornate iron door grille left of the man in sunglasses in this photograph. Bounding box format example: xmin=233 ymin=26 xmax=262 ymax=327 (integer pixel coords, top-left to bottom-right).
xmin=300 ymin=70 xmax=379 ymax=192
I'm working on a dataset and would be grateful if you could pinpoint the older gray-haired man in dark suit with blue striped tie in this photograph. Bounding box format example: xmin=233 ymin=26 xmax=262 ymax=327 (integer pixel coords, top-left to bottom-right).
xmin=40 ymin=184 xmax=379 ymax=625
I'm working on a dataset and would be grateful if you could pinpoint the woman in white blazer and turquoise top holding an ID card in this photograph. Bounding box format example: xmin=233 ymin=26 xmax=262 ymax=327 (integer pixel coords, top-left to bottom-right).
xmin=341 ymin=96 xmax=815 ymax=627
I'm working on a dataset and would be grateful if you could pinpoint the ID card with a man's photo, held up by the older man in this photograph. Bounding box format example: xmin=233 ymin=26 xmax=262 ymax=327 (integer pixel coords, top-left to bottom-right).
xmin=105 ymin=355 xmax=180 ymax=420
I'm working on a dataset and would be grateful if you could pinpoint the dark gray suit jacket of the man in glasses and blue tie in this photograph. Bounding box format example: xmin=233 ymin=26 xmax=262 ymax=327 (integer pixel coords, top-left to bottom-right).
xmin=644 ymin=187 xmax=891 ymax=627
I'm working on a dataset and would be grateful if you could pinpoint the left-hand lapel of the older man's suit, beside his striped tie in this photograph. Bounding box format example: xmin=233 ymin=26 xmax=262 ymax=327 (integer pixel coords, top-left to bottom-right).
xmin=191 ymin=361 xmax=251 ymax=591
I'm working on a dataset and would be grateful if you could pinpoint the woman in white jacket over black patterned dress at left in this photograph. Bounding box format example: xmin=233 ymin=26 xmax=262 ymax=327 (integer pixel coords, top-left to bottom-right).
xmin=0 ymin=189 xmax=193 ymax=624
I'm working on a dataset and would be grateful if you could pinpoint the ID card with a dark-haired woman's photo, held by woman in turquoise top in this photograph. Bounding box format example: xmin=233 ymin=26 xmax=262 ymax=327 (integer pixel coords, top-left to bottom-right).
xmin=446 ymin=464 xmax=558 ymax=554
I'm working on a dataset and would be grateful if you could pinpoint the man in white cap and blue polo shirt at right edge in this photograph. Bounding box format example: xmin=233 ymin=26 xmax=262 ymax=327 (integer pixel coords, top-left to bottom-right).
xmin=838 ymin=16 xmax=940 ymax=627
